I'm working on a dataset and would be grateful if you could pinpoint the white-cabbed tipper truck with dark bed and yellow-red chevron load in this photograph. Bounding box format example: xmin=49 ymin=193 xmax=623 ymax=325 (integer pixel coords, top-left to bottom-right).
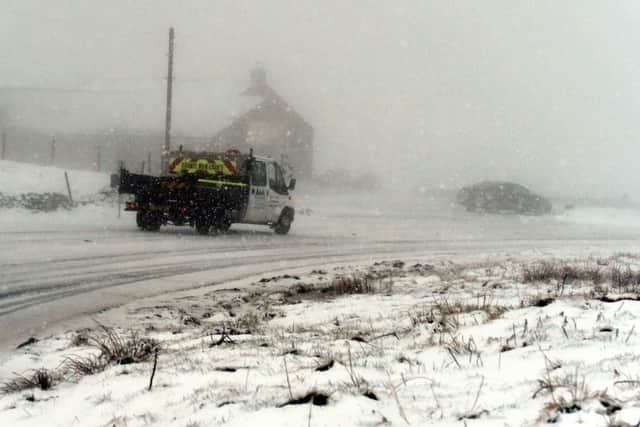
xmin=118 ymin=150 xmax=296 ymax=234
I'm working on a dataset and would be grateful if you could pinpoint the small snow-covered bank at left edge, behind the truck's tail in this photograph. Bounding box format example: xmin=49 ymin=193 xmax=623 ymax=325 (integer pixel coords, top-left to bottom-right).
xmin=0 ymin=160 xmax=109 ymax=200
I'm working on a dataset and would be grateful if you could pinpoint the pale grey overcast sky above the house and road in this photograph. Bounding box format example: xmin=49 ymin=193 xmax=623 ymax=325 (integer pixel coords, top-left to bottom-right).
xmin=0 ymin=0 xmax=640 ymax=199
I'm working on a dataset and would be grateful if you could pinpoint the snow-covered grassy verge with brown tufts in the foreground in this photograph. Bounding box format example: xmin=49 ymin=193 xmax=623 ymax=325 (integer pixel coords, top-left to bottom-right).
xmin=0 ymin=253 xmax=640 ymax=426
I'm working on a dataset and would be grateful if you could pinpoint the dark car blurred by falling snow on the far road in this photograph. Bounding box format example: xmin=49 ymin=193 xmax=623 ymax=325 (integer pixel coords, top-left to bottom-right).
xmin=457 ymin=181 xmax=551 ymax=215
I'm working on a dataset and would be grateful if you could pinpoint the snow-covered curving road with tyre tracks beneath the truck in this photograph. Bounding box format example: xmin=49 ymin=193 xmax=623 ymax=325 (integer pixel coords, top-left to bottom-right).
xmin=0 ymin=194 xmax=640 ymax=348
